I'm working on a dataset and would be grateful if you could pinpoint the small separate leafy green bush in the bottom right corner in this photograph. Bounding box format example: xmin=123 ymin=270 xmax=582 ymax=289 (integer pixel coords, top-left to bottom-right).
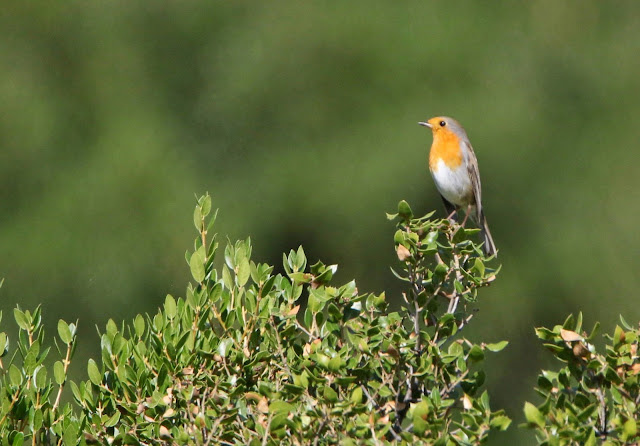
xmin=524 ymin=314 xmax=640 ymax=445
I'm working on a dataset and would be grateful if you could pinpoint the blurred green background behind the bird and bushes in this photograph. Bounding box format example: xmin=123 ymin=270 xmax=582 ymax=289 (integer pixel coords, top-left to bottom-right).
xmin=0 ymin=0 xmax=640 ymax=444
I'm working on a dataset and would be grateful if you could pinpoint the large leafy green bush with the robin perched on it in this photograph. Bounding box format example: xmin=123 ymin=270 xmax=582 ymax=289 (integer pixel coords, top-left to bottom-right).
xmin=0 ymin=195 xmax=510 ymax=445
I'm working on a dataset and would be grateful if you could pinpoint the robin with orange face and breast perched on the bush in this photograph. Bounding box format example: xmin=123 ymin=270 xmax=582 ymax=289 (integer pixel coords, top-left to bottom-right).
xmin=419 ymin=116 xmax=496 ymax=256
